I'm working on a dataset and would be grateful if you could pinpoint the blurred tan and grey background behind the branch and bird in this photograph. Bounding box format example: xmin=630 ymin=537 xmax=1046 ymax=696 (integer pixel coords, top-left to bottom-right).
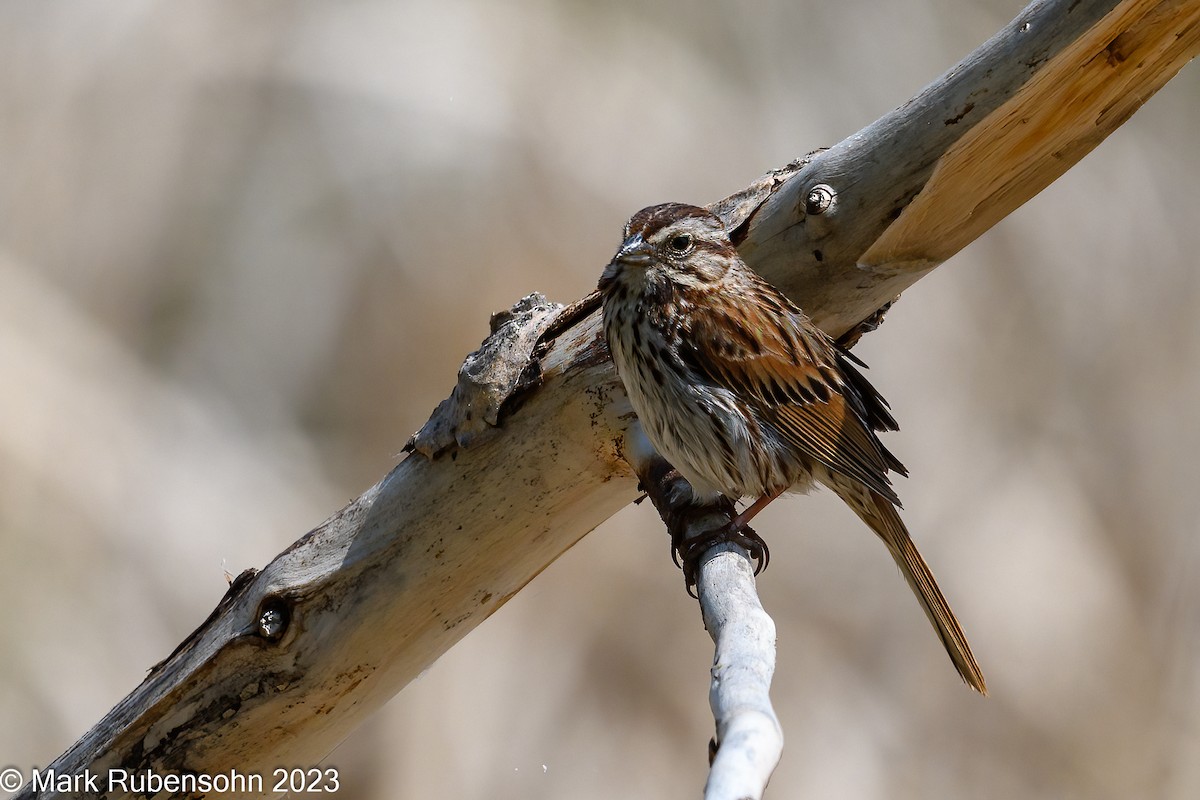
xmin=0 ymin=0 xmax=1200 ymax=800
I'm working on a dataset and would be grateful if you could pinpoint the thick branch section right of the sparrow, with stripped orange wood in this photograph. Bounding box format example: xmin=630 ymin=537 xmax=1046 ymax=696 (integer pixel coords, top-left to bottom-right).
xmin=738 ymin=0 xmax=1200 ymax=336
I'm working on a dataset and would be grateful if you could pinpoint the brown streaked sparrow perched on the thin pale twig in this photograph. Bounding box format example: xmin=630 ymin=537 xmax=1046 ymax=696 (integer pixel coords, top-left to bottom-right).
xmin=599 ymin=203 xmax=986 ymax=693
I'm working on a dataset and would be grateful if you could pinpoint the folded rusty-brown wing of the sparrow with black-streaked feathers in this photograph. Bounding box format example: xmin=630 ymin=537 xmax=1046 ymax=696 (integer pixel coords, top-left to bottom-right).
xmin=684 ymin=275 xmax=904 ymax=505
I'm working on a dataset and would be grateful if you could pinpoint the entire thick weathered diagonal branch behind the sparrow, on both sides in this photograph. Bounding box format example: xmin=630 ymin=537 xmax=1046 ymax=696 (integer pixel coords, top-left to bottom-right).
xmin=18 ymin=0 xmax=1200 ymax=798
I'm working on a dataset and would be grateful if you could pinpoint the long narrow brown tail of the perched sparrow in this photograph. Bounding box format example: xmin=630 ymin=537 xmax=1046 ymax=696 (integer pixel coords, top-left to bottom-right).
xmin=832 ymin=481 xmax=988 ymax=694
